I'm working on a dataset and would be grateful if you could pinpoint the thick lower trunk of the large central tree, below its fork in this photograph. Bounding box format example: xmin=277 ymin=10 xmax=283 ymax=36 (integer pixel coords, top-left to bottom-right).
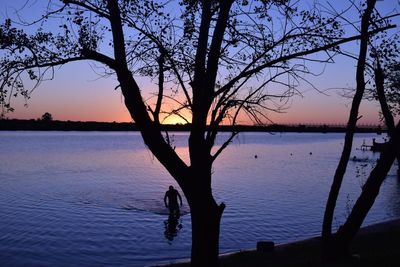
xmin=185 ymin=170 xmax=225 ymax=267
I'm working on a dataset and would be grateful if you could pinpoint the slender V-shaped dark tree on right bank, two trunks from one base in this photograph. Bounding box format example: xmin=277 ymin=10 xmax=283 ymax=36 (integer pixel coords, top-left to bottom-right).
xmin=322 ymin=0 xmax=398 ymax=261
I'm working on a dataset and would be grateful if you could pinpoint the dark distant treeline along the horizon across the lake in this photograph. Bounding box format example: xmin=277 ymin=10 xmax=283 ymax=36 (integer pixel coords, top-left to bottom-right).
xmin=0 ymin=119 xmax=385 ymax=133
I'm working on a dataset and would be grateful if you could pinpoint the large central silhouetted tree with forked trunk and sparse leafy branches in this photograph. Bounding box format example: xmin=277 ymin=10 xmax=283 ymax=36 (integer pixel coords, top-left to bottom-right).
xmin=0 ymin=0 xmax=394 ymax=266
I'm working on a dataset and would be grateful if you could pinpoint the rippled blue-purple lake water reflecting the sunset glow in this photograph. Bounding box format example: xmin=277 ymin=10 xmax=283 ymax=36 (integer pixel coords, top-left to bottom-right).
xmin=0 ymin=132 xmax=400 ymax=266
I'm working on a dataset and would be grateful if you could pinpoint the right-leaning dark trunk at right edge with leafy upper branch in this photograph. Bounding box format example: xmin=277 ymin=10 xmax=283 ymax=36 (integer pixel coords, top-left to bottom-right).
xmin=332 ymin=22 xmax=400 ymax=258
